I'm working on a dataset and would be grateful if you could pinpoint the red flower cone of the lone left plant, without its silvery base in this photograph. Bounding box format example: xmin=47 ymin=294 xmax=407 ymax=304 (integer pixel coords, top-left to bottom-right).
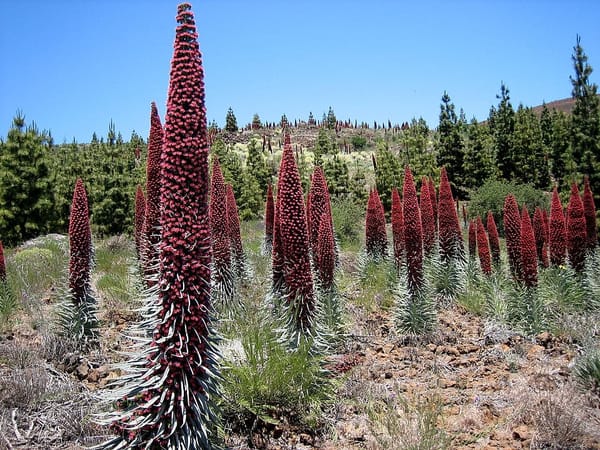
xmin=69 ymin=178 xmax=92 ymax=306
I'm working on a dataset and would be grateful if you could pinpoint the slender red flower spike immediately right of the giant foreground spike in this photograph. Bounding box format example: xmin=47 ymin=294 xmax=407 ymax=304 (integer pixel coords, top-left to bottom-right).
xmin=209 ymin=157 xmax=231 ymax=286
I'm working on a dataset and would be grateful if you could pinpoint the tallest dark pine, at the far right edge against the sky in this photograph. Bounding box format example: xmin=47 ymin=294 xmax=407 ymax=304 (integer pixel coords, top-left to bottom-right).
xmin=569 ymin=35 xmax=600 ymax=201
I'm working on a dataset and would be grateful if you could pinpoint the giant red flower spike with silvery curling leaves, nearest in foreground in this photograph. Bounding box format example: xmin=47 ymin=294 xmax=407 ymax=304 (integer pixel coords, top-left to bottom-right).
xmin=103 ymin=3 xmax=219 ymax=450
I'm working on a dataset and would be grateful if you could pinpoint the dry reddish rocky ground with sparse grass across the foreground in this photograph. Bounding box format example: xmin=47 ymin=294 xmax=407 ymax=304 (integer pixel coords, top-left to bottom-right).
xmin=0 ymin=241 xmax=600 ymax=450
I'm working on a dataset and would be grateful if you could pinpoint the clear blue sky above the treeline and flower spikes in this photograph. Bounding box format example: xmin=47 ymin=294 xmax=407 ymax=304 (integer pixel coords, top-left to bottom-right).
xmin=0 ymin=0 xmax=600 ymax=143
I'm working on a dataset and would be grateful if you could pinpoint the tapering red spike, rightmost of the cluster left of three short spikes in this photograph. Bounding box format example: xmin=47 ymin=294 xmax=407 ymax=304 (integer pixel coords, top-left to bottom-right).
xmin=438 ymin=167 xmax=464 ymax=259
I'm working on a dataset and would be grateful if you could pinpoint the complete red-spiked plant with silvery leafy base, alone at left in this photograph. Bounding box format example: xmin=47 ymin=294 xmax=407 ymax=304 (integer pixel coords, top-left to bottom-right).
xmin=58 ymin=178 xmax=98 ymax=349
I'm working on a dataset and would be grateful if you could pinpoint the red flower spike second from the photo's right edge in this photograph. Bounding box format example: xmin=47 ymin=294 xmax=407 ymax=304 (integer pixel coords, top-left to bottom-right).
xmin=567 ymin=183 xmax=587 ymax=272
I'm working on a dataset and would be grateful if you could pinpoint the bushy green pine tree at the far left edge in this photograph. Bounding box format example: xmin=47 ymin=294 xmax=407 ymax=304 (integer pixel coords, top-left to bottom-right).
xmin=0 ymin=112 xmax=52 ymax=245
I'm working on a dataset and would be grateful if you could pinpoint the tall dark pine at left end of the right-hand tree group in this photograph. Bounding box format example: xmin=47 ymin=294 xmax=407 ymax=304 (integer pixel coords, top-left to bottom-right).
xmin=436 ymin=91 xmax=466 ymax=199
